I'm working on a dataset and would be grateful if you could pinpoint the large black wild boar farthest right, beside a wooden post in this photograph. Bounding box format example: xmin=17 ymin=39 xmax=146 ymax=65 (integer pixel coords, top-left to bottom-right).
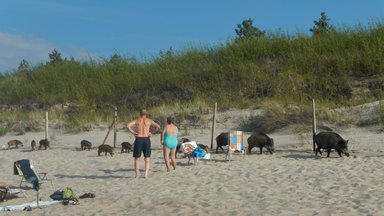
xmin=314 ymin=132 xmax=349 ymax=157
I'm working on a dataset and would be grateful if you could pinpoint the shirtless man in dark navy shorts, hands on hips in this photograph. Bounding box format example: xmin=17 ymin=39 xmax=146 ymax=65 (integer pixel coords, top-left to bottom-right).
xmin=127 ymin=109 xmax=160 ymax=178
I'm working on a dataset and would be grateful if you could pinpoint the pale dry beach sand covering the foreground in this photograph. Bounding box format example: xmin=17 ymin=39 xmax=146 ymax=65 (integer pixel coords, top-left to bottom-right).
xmin=0 ymin=112 xmax=384 ymax=215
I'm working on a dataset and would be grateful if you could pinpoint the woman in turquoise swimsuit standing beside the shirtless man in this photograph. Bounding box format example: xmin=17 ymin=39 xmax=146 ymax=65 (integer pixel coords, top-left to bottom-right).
xmin=161 ymin=117 xmax=178 ymax=172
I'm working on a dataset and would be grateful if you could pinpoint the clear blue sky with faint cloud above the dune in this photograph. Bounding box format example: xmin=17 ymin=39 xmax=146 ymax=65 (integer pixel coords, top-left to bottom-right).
xmin=0 ymin=0 xmax=384 ymax=72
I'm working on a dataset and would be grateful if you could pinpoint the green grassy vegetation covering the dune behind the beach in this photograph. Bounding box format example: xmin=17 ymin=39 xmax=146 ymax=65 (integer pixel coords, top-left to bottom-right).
xmin=0 ymin=14 xmax=384 ymax=131
